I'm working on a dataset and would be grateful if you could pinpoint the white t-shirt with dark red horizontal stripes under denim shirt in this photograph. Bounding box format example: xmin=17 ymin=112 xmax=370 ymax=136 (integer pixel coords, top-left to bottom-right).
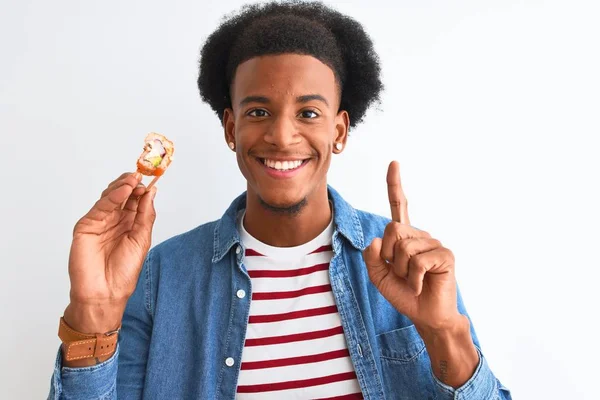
xmin=236 ymin=217 xmax=363 ymax=400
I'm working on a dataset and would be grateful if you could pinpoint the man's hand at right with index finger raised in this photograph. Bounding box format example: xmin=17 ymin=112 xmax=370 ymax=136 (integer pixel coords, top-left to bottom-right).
xmin=363 ymin=161 xmax=460 ymax=331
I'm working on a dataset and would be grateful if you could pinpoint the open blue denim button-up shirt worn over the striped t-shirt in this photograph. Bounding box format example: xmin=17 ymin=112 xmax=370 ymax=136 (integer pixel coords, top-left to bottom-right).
xmin=49 ymin=187 xmax=511 ymax=400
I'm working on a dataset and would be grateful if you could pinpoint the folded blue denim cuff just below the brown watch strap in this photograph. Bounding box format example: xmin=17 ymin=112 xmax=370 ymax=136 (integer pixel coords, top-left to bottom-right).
xmin=48 ymin=344 xmax=119 ymax=400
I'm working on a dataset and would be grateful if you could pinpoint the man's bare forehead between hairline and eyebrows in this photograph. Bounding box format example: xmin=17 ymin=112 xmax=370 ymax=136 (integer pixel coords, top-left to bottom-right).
xmin=231 ymin=54 xmax=337 ymax=104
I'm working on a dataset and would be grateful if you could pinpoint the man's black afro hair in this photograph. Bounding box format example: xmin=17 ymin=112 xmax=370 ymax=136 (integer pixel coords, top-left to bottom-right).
xmin=198 ymin=0 xmax=383 ymax=127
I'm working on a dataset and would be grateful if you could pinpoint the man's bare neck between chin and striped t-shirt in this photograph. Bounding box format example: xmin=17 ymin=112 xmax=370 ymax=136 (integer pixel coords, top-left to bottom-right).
xmin=243 ymin=183 xmax=332 ymax=247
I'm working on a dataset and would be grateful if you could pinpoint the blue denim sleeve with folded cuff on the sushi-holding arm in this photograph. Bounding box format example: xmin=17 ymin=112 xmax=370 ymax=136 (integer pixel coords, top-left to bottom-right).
xmin=48 ymin=251 xmax=153 ymax=400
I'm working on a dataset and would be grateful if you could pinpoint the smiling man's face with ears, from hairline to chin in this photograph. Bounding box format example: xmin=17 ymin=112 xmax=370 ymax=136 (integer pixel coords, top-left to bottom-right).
xmin=223 ymin=54 xmax=349 ymax=214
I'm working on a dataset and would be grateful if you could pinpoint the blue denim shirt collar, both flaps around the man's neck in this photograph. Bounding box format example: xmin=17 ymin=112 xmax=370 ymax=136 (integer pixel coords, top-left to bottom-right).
xmin=212 ymin=185 xmax=366 ymax=263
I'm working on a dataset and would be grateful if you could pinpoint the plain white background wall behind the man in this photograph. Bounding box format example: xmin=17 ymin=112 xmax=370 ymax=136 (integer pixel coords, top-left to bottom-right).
xmin=0 ymin=0 xmax=600 ymax=399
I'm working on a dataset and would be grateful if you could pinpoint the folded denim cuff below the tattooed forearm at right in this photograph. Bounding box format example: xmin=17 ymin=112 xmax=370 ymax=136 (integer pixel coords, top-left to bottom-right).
xmin=431 ymin=347 xmax=499 ymax=400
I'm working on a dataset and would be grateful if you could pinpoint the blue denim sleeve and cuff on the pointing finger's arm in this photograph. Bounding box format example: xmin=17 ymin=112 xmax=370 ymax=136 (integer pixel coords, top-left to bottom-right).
xmin=431 ymin=286 xmax=512 ymax=400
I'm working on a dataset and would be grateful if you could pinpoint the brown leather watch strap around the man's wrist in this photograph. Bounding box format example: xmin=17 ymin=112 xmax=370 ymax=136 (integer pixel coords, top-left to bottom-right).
xmin=58 ymin=317 xmax=121 ymax=361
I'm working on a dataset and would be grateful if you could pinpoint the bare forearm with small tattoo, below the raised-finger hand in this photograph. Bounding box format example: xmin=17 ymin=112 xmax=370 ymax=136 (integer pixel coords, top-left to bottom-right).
xmin=417 ymin=315 xmax=479 ymax=388
